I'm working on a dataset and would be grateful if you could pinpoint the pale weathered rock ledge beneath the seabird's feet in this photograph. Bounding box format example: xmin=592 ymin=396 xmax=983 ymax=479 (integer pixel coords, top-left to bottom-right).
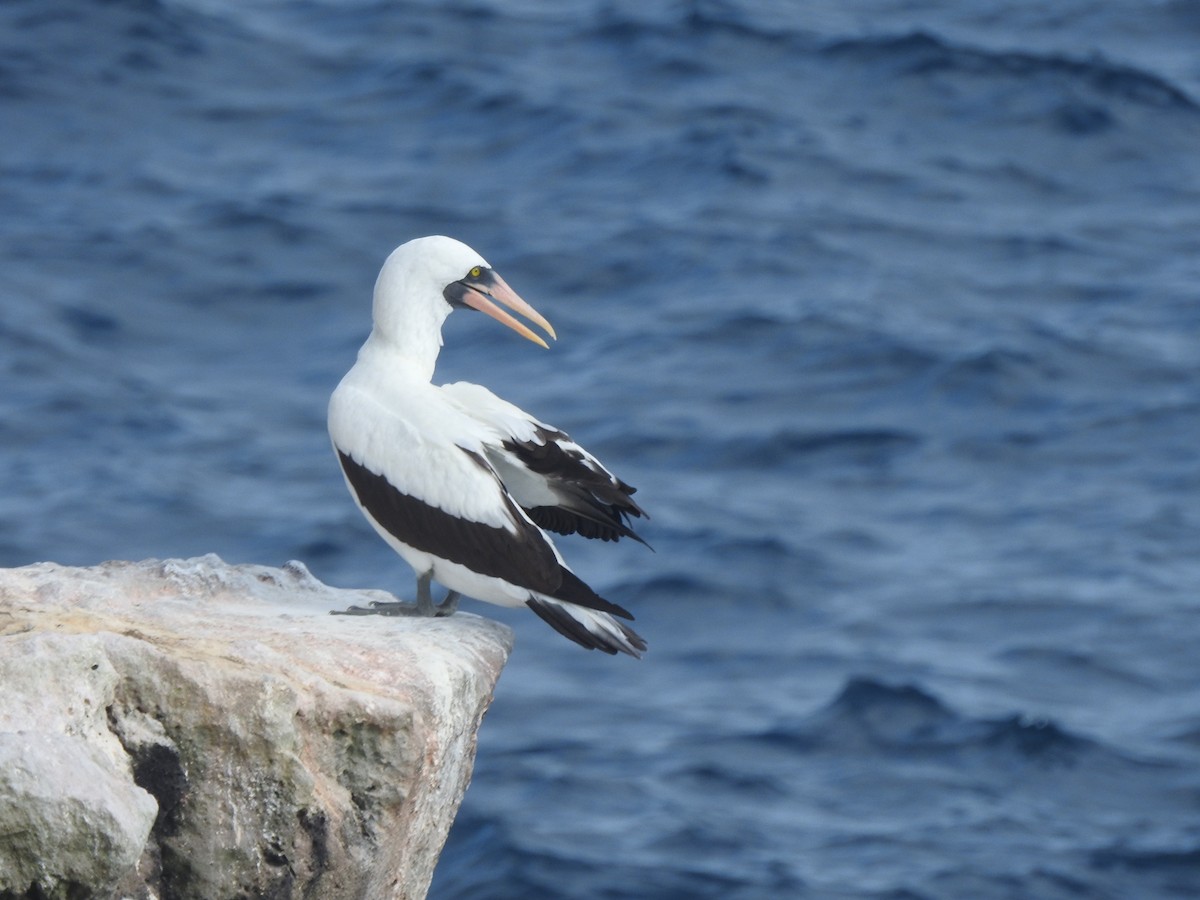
xmin=0 ymin=556 xmax=512 ymax=900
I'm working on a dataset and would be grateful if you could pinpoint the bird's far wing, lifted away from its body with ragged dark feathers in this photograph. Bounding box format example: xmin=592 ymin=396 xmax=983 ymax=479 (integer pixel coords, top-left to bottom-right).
xmin=442 ymin=382 xmax=646 ymax=544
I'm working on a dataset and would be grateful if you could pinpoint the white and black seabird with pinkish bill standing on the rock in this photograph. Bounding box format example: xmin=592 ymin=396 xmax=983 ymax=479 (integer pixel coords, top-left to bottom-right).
xmin=329 ymin=236 xmax=646 ymax=656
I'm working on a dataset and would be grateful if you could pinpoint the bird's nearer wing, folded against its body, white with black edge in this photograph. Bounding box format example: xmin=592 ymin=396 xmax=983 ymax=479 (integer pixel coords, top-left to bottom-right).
xmin=329 ymin=384 xmax=629 ymax=618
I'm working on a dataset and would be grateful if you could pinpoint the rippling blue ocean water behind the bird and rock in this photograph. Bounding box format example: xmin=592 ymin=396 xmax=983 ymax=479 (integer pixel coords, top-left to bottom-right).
xmin=0 ymin=0 xmax=1200 ymax=900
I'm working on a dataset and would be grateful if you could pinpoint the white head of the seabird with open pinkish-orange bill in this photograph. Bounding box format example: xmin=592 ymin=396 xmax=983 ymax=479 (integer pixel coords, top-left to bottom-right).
xmin=374 ymin=235 xmax=557 ymax=347
